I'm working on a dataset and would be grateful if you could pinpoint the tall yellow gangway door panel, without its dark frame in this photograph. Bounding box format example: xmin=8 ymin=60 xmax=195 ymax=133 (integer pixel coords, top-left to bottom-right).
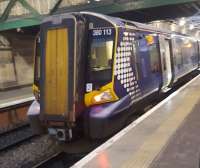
xmin=44 ymin=28 xmax=68 ymax=116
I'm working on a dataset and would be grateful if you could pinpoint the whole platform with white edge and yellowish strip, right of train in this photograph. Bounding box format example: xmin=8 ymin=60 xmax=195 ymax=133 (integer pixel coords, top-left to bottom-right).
xmin=72 ymin=76 xmax=200 ymax=168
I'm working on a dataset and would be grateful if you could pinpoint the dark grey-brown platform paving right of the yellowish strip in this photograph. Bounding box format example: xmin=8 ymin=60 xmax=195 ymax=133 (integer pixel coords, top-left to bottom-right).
xmin=150 ymin=99 xmax=200 ymax=168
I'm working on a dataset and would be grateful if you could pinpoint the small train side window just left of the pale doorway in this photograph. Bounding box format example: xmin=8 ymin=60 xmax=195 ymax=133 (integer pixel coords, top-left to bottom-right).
xmin=149 ymin=43 xmax=160 ymax=73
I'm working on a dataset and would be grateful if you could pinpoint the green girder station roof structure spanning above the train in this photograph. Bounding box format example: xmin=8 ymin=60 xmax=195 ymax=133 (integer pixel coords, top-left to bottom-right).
xmin=0 ymin=0 xmax=200 ymax=30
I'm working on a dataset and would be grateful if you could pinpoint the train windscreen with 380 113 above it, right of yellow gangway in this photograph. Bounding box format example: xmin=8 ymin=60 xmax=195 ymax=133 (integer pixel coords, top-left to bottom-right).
xmin=89 ymin=29 xmax=114 ymax=85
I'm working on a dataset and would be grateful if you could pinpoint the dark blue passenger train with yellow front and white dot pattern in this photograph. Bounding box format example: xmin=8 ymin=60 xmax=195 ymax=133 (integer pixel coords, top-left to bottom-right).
xmin=28 ymin=12 xmax=200 ymax=142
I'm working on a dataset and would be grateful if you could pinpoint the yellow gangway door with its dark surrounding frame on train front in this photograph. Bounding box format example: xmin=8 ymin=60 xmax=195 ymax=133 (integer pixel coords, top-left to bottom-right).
xmin=40 ymin=15 xmax=77 ymax=124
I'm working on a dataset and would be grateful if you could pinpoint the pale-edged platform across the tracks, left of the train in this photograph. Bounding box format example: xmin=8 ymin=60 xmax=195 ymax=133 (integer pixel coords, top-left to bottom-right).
xmin=0 ymin=86 xmax=34 ymax=109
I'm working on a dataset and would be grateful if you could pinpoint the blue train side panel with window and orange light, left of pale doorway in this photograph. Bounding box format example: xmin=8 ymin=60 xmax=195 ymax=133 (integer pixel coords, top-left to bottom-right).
xmin=136 ymin=34 xmax=161 ymax=96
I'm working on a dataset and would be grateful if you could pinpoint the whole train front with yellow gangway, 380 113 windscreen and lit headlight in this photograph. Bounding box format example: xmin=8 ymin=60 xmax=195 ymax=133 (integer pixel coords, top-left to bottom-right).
xmin=29 ymin=14 xmax=121 ymax=141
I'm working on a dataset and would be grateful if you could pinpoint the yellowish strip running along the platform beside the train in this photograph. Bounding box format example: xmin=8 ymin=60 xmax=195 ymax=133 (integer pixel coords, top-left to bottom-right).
xmin=122 ymin=88 xmax=199 ymax=168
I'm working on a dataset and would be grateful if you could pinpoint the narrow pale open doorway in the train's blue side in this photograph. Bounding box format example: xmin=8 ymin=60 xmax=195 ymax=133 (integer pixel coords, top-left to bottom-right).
xmin=159 ymin=35 xmax=172 ymax=92
